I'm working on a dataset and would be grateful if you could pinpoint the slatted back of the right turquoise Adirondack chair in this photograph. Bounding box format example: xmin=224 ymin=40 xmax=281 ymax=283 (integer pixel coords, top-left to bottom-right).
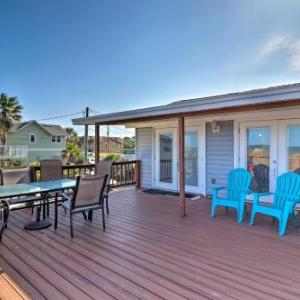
xmin=273 ymin=172 xmax=300 ymax=209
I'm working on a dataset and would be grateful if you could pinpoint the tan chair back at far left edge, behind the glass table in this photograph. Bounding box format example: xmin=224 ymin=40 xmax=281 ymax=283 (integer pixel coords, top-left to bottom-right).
xmin=0 ymin=168 xmax=31 ymax=185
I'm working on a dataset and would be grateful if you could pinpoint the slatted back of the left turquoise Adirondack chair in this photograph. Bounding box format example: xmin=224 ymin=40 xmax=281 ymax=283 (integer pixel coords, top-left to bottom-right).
xmin=227 ymin=168 xmax=251 ymax=201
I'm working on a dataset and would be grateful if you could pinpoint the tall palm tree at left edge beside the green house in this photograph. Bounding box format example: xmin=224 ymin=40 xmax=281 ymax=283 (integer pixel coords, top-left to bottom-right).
xmin=0 ymin=93 xmax=23 ymax=145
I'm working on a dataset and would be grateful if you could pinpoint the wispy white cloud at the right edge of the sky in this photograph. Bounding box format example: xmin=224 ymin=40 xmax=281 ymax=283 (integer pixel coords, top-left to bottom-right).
xmin=260 ymin=35 xmax=300 ymax=71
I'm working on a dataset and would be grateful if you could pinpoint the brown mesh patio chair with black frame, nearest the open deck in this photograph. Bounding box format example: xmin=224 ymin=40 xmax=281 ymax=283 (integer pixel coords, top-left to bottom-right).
xmin=63 ymin=174 xmax=108 ymax=238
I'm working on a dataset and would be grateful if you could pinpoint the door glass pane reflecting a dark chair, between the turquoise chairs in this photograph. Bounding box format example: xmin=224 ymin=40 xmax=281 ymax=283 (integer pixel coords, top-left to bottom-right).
xmin=247 ymin=127 xmax=270 ymax=193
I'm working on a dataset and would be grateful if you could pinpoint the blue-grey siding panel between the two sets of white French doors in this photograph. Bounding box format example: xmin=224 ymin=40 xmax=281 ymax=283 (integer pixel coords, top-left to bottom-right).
xmin=206 ymin=121 xmax=234 ymax=194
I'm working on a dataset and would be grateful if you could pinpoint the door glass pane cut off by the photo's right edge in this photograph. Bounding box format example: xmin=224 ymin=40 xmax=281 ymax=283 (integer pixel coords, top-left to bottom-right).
xmin=288 ymin=126 xmax=300 ymax=174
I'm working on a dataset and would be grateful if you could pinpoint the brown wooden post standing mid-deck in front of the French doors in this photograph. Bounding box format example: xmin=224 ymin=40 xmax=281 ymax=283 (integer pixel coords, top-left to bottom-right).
xmin=178 ymin=117 xmax=185 ymax=217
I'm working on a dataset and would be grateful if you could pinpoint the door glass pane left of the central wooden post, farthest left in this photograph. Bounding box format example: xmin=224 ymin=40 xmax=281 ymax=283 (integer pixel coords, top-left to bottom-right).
xmin=159 ymin=133 xmax=173 ymax=183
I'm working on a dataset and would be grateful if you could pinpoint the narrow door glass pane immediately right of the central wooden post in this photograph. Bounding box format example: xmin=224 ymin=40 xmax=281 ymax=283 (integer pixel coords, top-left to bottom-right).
xmin=185 ymin=132 xmax=198 ymax=186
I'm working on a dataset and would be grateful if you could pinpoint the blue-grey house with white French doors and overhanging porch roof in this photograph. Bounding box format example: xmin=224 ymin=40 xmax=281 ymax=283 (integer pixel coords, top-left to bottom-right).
xmin=73 ymin=83 xmax=300 ymax=198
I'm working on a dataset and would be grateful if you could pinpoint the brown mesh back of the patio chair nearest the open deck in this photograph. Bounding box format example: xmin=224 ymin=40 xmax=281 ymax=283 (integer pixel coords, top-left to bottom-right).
xmin=72 ymin=175 xmax=108 ymax=209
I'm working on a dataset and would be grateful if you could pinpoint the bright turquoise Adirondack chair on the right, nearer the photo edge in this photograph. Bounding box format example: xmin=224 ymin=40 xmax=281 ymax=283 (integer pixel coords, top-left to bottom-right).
xmin=250 ymin=172 xmax=300 ymax=235
